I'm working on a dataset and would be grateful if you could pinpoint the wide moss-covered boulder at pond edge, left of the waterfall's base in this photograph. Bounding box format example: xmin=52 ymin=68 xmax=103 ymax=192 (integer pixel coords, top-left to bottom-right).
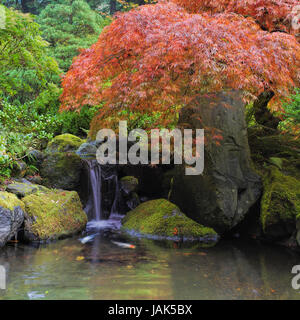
xmin=23 ymin=190 xmax=87 ymax=241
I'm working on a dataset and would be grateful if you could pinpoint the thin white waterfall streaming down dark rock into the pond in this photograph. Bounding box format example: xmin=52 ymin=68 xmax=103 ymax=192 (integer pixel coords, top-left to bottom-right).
xmin=84 ymin=160 xmax=119 ymax=221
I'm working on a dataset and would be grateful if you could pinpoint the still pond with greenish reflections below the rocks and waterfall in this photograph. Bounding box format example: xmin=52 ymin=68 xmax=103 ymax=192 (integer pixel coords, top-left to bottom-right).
xmin=0 ymin=217 xmax=300 ymax=300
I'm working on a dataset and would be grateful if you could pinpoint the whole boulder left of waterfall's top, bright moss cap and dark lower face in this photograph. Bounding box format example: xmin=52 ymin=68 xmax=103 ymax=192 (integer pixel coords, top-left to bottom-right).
xmin=41 ymin=134 xmax=84 ymax=190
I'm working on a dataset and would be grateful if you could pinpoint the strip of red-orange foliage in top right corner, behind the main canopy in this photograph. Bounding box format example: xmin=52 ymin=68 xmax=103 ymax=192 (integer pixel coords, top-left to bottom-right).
xmin=171 ymin=0 xmax=300 ymax=35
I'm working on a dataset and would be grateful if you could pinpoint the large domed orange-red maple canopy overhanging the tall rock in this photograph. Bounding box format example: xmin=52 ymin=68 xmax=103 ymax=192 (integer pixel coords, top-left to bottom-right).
xmin=61 ymin=1 xmax=300 ymax=129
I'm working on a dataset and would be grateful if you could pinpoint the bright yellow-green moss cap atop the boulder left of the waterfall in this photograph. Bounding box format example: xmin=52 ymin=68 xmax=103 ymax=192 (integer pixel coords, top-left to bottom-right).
xmin=46 ymin=133 xmax=85 ymax=154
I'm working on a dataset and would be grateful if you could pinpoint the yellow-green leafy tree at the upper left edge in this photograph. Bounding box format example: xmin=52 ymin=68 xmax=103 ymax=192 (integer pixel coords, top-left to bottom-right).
xmin=0 ymin=5 xmax=60 ymax=103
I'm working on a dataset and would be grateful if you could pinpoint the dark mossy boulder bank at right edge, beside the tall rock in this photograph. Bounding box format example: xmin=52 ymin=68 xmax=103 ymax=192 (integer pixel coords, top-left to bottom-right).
xmin=248 ymin=126 xmax=300 ymax=246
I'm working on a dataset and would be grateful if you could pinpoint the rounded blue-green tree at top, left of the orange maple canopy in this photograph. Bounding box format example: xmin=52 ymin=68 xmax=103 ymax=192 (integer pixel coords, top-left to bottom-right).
xmin=37 ymin=0 xmax=109 ymax=71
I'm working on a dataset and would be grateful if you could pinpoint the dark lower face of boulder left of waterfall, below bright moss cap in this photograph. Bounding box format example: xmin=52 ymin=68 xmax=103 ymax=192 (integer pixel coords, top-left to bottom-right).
xmin=40 ymin=152 xmax=83 ymax=190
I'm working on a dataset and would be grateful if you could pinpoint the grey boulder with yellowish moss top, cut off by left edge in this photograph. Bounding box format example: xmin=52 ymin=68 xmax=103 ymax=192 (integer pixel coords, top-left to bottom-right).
xmin=0 ymin=192 xmax=25 ymax=247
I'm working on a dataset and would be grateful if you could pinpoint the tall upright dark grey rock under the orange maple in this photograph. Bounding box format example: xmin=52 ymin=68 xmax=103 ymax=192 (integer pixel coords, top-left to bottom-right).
xmin=170 ymin=91 xmax=262 ymax=233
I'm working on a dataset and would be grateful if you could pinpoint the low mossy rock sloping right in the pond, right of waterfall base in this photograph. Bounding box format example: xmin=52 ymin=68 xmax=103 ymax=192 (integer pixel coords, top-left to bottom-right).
xmin=122 ymin=199 xmax=218 ymax=242
